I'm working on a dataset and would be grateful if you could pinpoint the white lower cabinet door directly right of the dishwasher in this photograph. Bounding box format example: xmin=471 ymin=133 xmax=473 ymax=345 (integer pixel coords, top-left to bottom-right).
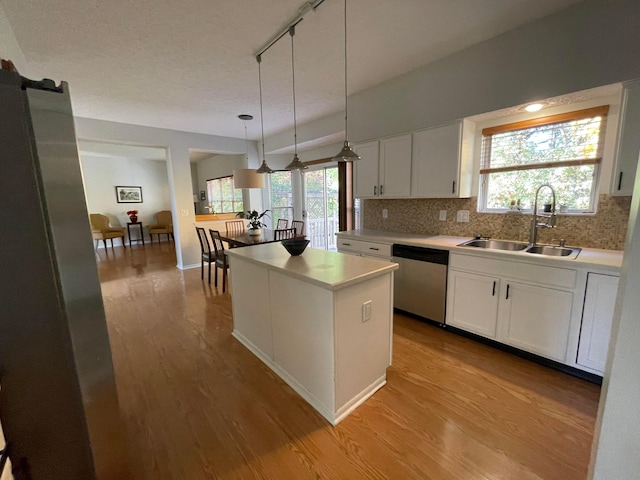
xmin=446 ymin=270 xmax=500 ymax=338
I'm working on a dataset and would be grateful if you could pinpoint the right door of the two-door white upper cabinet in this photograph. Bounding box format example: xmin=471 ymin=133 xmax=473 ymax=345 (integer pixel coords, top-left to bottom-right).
xmin=378 ymin=134 xmax=411 ymax=198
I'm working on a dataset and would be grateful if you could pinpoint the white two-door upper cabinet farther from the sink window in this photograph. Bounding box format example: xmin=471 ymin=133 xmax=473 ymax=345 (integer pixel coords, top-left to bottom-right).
xmin=354 ymin=134 xmax=411 ymax=198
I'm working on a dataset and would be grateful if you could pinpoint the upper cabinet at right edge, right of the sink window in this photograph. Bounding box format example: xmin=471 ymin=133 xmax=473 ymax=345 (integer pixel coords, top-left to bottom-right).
xmin=611 ymin=80 xmax=640 ymax=196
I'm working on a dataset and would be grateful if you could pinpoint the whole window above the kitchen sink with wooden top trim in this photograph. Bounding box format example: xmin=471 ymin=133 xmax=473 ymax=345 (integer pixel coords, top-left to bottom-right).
xmin=480 ymin=106 xmax=609 ymax=213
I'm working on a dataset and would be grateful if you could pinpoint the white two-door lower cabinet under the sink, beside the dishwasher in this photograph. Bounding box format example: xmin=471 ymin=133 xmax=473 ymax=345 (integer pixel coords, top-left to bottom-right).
xmin=446 ymin=254 xmax=576 ymax=363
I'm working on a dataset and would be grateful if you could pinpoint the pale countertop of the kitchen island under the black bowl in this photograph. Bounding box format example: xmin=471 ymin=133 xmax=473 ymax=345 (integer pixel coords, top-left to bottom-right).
xmin=225 ymin=242 xmax=398 ymax=290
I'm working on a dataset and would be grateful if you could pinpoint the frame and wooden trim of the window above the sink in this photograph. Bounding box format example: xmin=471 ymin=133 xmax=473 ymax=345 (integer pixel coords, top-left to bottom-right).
xmin=478 ymin=105 xmax=609 ymax=215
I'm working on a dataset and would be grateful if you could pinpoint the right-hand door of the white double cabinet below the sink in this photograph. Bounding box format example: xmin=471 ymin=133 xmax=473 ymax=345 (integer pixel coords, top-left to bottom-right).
xmin=499 ymin=282 xmax=573 ymax=362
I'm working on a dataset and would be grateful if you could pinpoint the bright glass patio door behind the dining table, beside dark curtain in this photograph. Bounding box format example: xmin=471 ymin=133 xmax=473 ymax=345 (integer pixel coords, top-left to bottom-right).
xmin=303 ymin=166 xmax=339 ymax=250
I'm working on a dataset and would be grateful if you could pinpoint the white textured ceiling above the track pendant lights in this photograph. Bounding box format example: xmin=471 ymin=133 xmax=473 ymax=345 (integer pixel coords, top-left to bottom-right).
xmin=6 ymin=0 xmax=580 ymax=141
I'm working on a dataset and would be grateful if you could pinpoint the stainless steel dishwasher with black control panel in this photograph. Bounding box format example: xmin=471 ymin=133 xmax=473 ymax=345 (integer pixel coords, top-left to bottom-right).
xmin=393 ymin=244 xmax=449 ymax=324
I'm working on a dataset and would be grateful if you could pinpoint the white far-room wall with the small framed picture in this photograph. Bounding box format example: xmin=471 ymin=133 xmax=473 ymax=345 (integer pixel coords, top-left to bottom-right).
xmin=80 ymin=155 xmax=171 ymax=245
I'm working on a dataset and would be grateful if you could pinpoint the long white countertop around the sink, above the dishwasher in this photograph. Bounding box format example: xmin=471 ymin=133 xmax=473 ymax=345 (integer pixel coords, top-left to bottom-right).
xmin=336 ymin=229 xmax=624 ymax=273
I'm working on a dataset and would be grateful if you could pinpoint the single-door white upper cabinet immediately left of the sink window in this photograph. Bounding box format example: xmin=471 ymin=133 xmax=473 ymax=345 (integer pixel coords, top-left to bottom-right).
xmin=411 ymin=120 xmax=474 ymax=198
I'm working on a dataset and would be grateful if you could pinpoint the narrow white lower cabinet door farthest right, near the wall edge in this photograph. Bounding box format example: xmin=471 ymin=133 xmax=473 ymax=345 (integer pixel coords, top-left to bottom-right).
xmin=577 ymin=273 xmax=618 ymax=373
